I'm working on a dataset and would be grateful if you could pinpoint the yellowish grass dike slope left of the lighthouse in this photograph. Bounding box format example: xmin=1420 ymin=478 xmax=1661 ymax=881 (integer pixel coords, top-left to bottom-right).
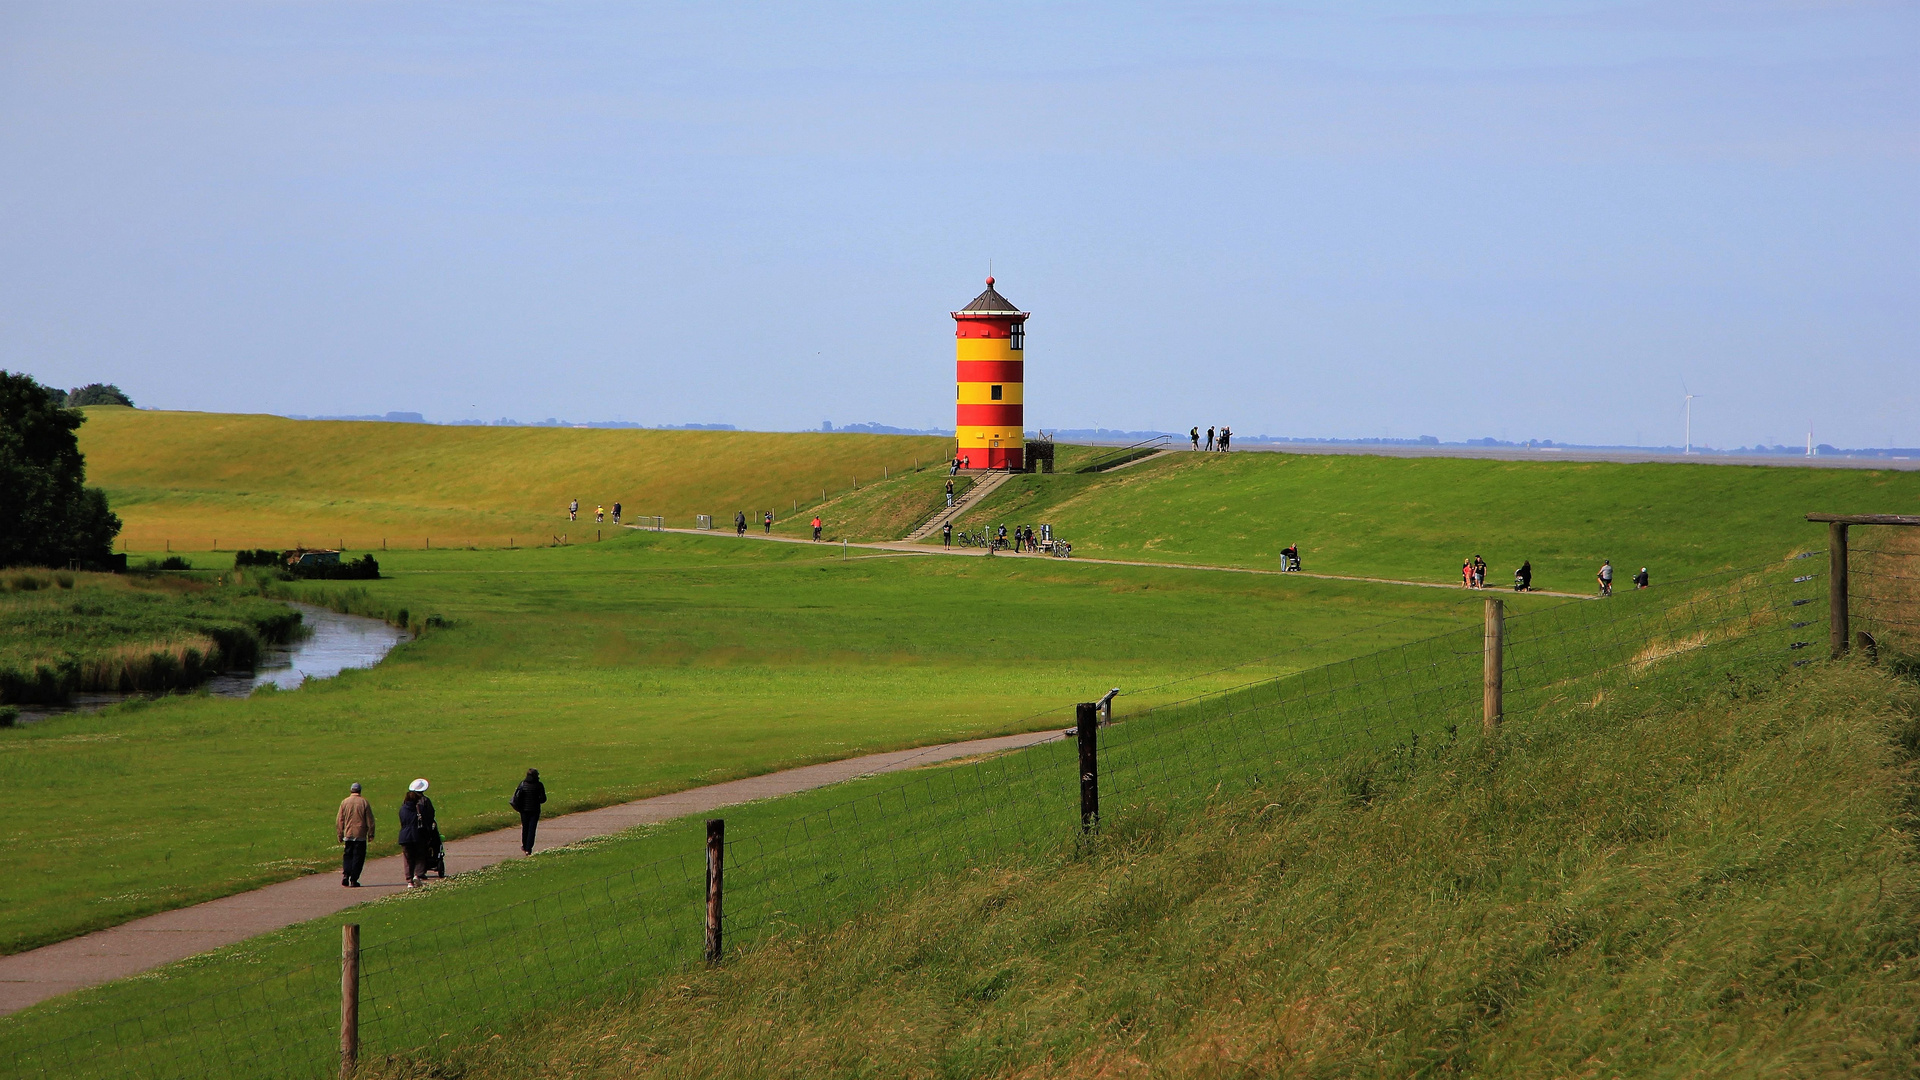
xmin=81 ymin=407 xmax=948 ymax=552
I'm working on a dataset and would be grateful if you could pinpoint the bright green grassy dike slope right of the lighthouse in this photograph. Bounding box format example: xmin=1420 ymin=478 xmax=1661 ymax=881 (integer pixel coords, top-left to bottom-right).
xmin=921 ymin=443 xmax=1920 ymax=592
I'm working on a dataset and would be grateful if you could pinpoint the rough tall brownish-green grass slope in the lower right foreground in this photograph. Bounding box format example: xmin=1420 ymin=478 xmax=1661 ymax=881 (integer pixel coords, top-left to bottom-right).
xmin=374 ymin=663 xmax=1920 ymax=1080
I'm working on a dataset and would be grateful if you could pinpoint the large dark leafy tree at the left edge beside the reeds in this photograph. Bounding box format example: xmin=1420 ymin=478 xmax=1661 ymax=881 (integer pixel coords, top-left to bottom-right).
xmin=0 ymin=371 xmax=121 ymax=567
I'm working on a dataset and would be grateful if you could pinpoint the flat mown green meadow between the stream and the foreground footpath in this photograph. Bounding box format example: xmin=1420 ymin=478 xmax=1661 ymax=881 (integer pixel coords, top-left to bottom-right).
xmin=0 ymin=532 xmax=1478 ymax=951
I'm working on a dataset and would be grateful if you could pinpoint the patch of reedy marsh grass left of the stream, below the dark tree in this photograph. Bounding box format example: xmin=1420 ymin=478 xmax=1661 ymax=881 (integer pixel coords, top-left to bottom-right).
xmin=0 ymin=571 xmax=300 ymax=705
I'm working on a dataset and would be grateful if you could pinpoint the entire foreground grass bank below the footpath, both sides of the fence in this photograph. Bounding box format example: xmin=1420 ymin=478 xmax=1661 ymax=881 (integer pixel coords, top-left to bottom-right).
xmin=0 ymin=567 xmax=1881 ymax=1076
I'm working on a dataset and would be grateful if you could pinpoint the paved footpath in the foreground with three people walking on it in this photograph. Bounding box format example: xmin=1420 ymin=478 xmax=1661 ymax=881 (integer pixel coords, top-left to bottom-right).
xmin=0 ymin=730 xmax=1060 ymax=1015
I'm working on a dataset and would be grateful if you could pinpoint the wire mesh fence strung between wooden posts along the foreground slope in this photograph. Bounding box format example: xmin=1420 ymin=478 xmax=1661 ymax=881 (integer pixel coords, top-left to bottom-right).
xmin=0 ymin=550 xmax=1858 ymax=1080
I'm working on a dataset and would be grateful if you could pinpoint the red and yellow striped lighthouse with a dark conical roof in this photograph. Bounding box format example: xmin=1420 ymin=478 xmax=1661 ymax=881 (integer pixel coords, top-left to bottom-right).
xmin=952 ymin=277 xmax=1027 ymax=471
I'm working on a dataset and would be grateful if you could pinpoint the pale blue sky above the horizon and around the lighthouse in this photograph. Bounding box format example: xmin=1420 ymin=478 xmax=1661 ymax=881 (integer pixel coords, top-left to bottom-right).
xmin=0 ymin=0 xmax=1920 ymax=446
